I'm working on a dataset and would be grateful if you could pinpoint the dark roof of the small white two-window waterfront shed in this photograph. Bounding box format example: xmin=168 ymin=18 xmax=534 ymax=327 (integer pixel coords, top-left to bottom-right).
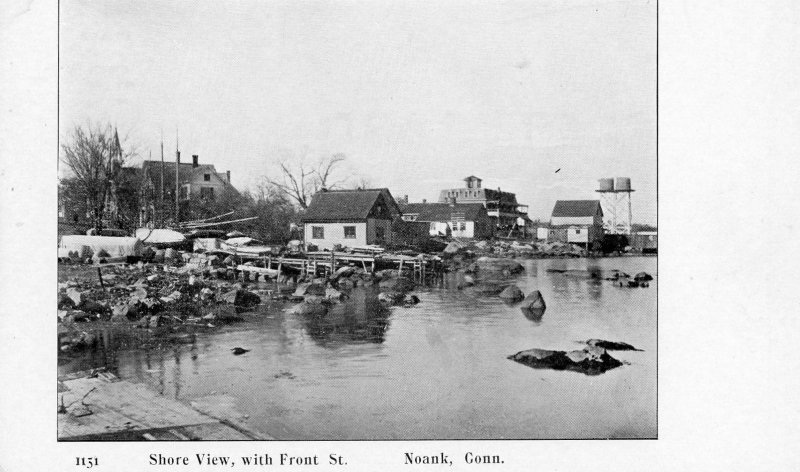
xmin=302 ymin=188 xmax=400 ymax=221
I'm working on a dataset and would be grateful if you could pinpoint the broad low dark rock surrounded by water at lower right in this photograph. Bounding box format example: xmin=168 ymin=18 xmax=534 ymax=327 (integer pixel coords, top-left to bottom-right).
xmin=508 ymin=346 xmax=622 ymax=375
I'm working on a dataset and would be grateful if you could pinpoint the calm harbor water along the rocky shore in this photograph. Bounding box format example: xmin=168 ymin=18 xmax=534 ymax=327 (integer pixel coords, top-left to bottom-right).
xmin=60 ymin=257 xmax=657 ymax=440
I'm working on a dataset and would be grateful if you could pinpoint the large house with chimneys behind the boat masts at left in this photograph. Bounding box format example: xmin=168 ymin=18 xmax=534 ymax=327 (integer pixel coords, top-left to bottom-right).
xmin=139 ymin=154 xmax=237 ymax=226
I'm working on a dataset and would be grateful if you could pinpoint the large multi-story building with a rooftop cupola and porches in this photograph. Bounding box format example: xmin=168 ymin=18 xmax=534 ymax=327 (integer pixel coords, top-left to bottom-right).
xmin=439 ymin=175 xmax=530 ymax=234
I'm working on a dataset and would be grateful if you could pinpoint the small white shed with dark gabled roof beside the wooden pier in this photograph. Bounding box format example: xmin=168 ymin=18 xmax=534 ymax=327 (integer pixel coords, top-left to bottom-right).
xmin=302 ymin=188 xmax=401 ymax=250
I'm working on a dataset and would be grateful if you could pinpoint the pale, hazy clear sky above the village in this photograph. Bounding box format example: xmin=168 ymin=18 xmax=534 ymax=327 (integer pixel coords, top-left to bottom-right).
xmin=59 ymin=0 xmax=656 ymax=224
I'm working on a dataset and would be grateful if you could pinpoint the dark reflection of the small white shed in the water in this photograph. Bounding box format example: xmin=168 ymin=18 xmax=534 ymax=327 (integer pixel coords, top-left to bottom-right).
xmin=304 ymin=290 xmax=391 ymax=346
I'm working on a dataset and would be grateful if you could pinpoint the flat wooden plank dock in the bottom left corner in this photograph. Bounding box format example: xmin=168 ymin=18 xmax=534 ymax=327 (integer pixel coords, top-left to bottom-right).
xmin=58 ymin=372 xmax=272 ymax=441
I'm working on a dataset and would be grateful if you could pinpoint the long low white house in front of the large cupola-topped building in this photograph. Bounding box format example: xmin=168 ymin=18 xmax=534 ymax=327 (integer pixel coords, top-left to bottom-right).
xmin=400 ymin=200 xmax=494 ymax=239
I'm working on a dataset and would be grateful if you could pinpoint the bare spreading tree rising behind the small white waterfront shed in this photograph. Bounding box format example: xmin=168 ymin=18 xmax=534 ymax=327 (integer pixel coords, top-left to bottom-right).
xmin=265 ymin=154 xmax=346 ymax=209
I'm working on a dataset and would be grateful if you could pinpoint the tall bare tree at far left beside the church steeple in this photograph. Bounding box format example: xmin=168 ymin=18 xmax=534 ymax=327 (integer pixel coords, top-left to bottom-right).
xmin=61 ymin=125 xmax=133 ymax=228
